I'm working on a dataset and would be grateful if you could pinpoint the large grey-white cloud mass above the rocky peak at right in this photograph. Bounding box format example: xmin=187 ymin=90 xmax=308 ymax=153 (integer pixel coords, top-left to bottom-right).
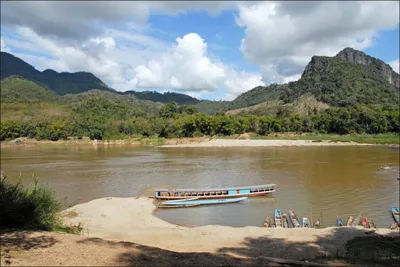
xmin=236 ymin=1 xmax=399 ymax=82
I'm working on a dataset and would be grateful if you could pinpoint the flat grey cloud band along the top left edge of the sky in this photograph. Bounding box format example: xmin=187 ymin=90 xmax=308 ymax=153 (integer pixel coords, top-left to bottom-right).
xmin=1 ymin=1 xmax=233 ymax=40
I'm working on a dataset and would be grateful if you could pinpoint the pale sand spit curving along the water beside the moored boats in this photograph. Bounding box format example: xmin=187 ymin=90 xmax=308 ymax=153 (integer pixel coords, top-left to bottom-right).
xmin=59 ymin=198 xmax=393 ymax=260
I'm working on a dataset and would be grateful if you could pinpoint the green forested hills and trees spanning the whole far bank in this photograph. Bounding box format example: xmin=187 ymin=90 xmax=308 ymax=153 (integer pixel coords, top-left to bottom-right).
xmin=0 ymin=48 xmax=400 ymax=144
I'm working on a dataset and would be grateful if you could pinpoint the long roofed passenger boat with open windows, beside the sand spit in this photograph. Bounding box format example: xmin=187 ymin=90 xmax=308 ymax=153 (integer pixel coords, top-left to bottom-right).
xmin=153 ymin=184 xmax=276 ymax=200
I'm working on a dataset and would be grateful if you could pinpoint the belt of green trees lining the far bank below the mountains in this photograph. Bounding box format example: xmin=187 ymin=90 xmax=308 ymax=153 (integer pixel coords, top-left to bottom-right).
xmin=0 ymin=101 xmax=400 ymax=143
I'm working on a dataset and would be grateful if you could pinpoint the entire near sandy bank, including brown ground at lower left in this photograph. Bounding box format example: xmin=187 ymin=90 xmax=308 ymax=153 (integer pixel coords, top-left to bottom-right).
xmin=2 ymin=197 xmax=396 ymax=266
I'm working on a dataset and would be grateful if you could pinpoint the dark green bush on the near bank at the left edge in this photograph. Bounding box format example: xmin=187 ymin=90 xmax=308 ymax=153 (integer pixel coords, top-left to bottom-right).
xmin=0 ymin=174 xmax=82 ymax=234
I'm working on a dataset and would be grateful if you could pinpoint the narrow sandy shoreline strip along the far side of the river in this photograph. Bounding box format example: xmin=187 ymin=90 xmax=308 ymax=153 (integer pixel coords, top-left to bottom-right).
xmin=0 ymin=133 xmax=400 ymax=148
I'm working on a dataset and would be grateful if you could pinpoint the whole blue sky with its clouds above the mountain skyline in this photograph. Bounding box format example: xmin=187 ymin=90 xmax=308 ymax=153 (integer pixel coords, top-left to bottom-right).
xmin=1 ymin=1 xmax=399 ymax=100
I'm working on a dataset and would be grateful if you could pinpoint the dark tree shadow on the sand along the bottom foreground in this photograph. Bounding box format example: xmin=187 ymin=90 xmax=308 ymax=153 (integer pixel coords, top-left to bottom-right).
xmin=79 ymin=227 xmax=400 ymax=266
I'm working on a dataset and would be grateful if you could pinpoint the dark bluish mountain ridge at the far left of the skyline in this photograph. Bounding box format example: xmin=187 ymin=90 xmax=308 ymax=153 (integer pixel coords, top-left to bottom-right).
xmin=0 ymin=52 xmax=115 ymax=95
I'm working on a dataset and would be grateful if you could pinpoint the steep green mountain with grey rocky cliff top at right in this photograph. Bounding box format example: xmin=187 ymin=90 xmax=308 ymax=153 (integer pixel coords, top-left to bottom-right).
xmin=229 ymin=48 xmax=399 ymax=114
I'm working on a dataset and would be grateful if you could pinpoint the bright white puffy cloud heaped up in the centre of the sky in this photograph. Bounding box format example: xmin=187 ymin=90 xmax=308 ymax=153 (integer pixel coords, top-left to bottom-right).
xmin=132 ymin=33 xmax=264 ymax=96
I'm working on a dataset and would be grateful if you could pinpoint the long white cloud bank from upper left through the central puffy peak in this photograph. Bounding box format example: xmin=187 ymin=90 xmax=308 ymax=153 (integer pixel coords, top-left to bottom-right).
xmin=5 ymin=27 xmax=264 ymax=98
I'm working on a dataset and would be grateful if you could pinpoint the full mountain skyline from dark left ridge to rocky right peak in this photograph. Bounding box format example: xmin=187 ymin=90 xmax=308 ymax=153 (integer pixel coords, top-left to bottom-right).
xmin=1 ymin=47 xmax=400 ymax=114
